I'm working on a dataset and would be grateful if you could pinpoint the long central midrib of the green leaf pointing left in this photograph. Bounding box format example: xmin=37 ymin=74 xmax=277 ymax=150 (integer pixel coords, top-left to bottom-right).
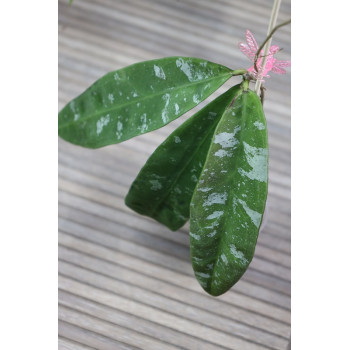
xmin=58 ymin=71 xmax=232 ymax=129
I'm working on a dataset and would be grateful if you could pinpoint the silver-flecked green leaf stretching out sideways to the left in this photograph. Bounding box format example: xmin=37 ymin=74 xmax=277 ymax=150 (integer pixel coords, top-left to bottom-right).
xmin=58 ymin=57 xmax=233 ymax=148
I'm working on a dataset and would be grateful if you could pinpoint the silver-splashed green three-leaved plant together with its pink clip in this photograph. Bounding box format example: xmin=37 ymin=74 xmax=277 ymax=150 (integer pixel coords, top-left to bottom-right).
xmin=58 ymin=26 xmax=290 ymax=296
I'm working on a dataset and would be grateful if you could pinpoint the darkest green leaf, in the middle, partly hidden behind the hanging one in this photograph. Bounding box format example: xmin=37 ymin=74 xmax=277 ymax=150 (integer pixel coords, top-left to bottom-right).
xmin=125 ymin=85 xmax=240 ymax=231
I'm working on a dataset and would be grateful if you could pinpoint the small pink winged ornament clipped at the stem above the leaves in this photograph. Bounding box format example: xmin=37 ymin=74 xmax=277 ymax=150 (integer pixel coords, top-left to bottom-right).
xmin=238 ymin=30 xmax=290 ymax=80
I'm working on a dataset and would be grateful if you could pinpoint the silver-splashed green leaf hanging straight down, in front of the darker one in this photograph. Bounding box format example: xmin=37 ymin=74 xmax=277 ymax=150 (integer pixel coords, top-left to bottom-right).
xmin=190 ymin=90 xmax=268 ymax=296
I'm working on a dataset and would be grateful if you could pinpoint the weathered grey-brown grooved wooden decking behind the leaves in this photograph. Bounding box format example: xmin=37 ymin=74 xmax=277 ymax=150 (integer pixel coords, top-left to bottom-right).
xmin=58 ymin=0 xmax=290 ymax=350
